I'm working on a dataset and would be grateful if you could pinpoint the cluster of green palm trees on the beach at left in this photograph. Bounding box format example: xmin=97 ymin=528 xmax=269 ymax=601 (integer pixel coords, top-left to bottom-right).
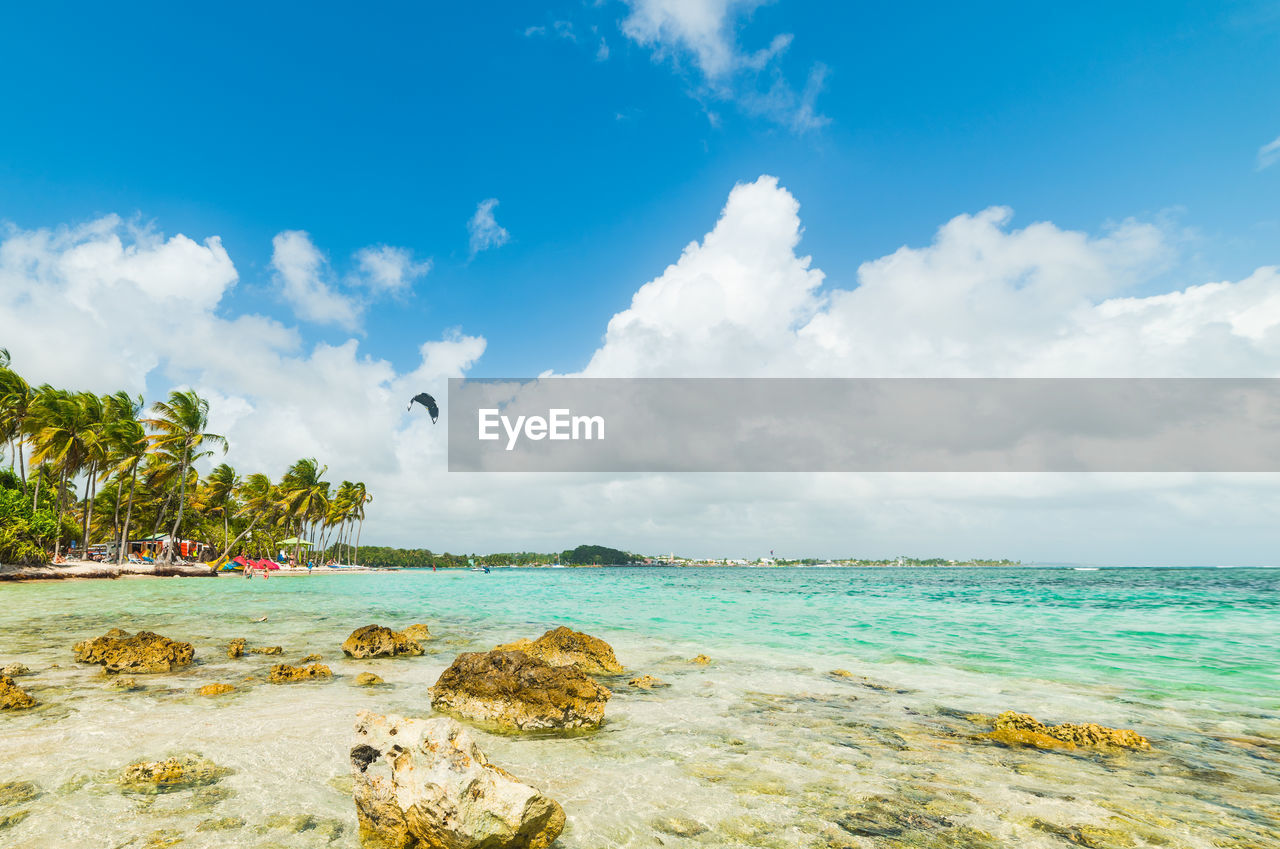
xmin=0 ymin=348 xmax=372 ymax=563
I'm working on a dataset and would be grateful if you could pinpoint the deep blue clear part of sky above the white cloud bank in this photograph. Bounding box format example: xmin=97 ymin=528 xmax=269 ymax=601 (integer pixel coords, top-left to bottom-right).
xmin=0 ymin=0 xmax=1280 ymax=374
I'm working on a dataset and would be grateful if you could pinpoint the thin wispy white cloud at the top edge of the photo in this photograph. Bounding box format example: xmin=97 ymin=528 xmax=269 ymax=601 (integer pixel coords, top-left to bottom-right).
xmin=621 ymin=0 xmax=829 ymax=133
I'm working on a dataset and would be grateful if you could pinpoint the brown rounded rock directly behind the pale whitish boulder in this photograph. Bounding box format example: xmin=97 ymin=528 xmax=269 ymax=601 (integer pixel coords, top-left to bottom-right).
xmin=431 ymin=651 xmax=609 ymax=731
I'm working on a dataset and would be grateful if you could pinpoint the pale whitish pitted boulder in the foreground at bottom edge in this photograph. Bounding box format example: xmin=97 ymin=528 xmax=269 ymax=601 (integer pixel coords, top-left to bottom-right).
xmin=351 ymin=711 xmax=564 ymax=849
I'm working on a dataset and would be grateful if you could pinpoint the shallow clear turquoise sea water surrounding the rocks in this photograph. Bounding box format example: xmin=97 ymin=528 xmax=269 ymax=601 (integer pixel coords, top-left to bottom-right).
xmin=0 ymin=569 xmax=1280 ymax=849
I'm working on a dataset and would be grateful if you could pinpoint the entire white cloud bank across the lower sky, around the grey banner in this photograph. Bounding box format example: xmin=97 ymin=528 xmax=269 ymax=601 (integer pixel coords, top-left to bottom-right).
xmin=0 ymin=185 xmax=1280 ymax=562
